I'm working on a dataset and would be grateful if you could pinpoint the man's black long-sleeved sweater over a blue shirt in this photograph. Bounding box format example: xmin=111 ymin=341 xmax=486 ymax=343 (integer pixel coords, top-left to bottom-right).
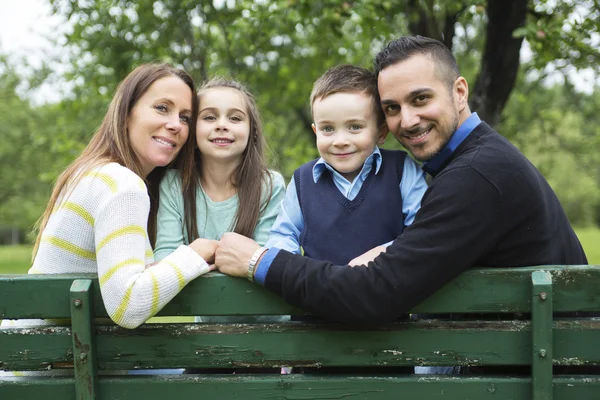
xmin=265 ymin=122 xmax=587 ymax=322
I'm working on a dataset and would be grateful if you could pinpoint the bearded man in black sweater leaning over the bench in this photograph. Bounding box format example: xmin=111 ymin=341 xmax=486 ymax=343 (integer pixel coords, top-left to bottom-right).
xmin=216 ymin=37 xmax=587 ymax=322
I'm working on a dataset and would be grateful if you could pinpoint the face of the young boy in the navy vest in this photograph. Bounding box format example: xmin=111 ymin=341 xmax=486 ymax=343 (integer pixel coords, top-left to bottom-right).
xmin=312 ymin=92 xmax=387 ymax=182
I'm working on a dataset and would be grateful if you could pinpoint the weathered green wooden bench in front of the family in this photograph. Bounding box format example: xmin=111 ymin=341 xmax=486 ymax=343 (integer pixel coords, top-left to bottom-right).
xmin=0 ymin=266 xmax=600 ymax=400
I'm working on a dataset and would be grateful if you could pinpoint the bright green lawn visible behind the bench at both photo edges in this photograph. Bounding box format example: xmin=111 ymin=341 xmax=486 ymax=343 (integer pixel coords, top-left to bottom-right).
xmin=0 ymin=228 xmax=600 ymax=274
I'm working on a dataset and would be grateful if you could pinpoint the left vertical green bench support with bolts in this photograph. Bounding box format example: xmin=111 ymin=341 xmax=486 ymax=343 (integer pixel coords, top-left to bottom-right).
xmin=70 ymin=279 xmax=98 ymax=400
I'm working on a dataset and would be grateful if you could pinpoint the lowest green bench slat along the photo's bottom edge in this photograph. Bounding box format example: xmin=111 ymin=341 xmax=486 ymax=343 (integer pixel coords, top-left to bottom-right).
xmin=0 ymin=375 xmax=600 ymax=400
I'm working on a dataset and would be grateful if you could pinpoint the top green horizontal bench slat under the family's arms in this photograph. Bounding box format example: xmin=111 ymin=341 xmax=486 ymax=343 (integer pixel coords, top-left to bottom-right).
xmin=0 ymin=266 xmax=600 ymax=318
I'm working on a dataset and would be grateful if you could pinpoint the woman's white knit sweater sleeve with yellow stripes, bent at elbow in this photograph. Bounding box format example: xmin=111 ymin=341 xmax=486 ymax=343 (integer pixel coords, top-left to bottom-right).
xmin=94 ymin=185 xmax=208 ymax=328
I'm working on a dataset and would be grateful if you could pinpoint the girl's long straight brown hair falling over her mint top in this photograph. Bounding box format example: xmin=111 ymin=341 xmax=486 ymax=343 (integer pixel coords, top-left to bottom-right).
xmin=178 ymin=77 xmax=273 ymax=242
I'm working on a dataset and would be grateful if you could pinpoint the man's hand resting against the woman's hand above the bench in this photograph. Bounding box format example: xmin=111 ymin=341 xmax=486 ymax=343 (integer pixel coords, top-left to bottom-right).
xmin=215 ymin=232 xmax=260 ymax=278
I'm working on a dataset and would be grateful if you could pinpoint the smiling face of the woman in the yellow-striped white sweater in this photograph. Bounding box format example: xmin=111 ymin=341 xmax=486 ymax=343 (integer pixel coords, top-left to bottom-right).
xmin=127 ymin=76 xmax=194 ymax=178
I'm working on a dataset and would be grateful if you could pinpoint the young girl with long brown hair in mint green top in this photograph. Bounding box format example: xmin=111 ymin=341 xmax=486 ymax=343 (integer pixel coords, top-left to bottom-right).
xmin=155 ymin=78 xmax=285 ymax=259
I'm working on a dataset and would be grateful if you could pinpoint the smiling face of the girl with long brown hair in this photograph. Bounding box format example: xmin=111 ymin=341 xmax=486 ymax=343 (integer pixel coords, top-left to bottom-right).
xmin=196 ymin=87 xmax=250 ymax=164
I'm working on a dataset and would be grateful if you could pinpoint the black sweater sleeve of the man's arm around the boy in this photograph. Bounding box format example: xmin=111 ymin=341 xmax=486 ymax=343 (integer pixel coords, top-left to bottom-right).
xmin=265 ymin=167 xmax=510 ymax=322
